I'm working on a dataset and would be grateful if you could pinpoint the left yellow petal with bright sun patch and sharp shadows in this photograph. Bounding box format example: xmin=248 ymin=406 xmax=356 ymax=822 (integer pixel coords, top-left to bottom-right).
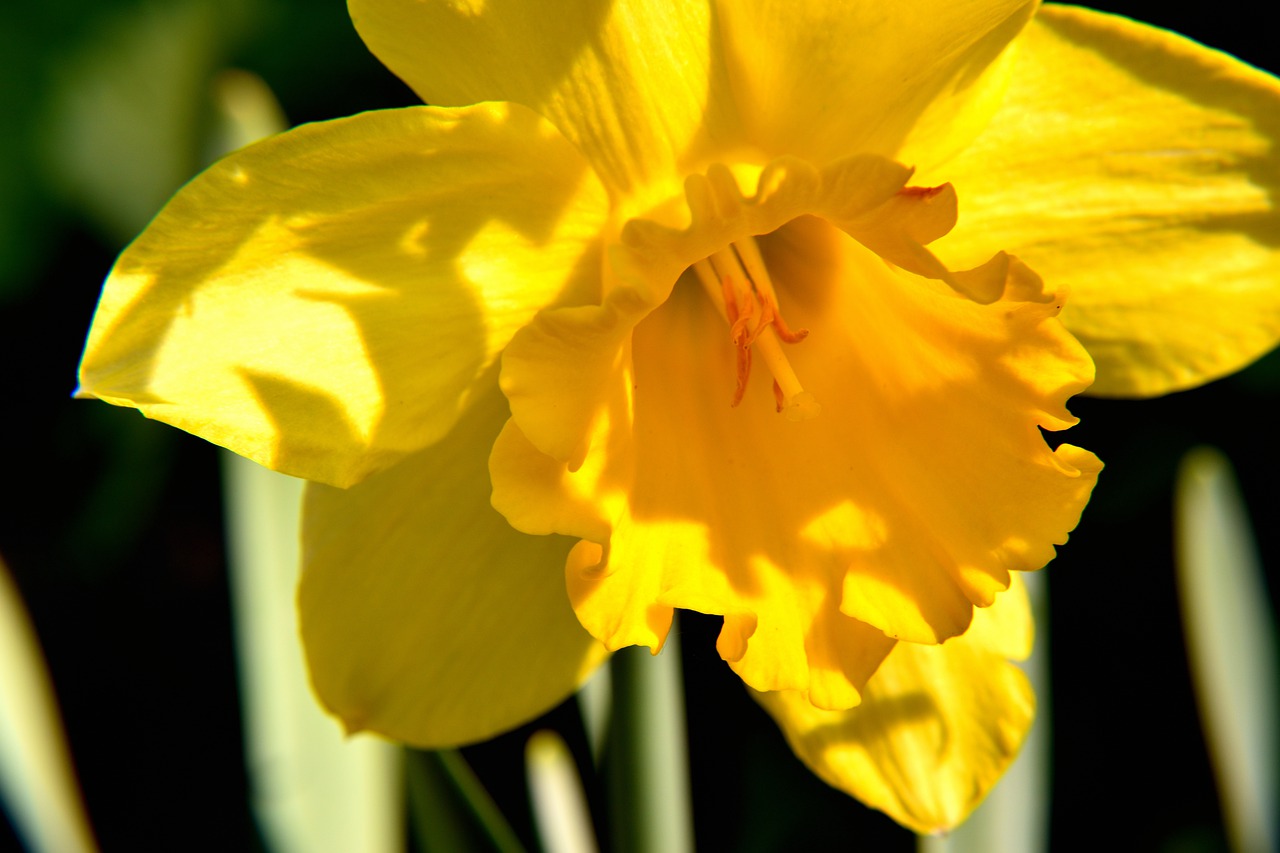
xmin=79 ymin=105 xmax=605 ymax=485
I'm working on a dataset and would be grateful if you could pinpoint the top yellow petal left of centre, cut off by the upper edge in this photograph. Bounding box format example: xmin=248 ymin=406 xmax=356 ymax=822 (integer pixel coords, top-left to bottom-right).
xmin=348 ymin=0 xmax=737 ymax=209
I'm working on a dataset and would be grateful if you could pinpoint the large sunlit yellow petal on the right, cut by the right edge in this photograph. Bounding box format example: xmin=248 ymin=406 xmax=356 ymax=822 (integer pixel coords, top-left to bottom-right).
xmin=923 ymin=5 xmax=1280 ymax=396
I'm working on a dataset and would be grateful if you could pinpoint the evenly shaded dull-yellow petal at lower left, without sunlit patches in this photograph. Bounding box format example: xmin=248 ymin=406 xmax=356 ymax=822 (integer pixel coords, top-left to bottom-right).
xmin=298 ymin=382 xmax=605 ymax=747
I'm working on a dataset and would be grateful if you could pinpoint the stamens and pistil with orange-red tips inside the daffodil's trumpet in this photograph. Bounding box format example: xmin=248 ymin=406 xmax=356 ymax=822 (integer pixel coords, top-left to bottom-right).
xmin=694 ymin=237 xmax=822 ymax=420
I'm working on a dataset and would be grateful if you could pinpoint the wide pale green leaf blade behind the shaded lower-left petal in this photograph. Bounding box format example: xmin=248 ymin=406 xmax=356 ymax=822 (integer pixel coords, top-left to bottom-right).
xmin=223 ymin=451 xmax=403 ymax=853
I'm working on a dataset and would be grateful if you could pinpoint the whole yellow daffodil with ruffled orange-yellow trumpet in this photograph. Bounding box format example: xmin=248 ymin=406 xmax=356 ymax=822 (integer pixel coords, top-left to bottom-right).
xmin=72 ymin=0 xmax=1280 ymax=831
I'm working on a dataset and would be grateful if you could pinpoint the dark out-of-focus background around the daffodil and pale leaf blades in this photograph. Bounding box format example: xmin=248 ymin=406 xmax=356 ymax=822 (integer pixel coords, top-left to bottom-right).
xmin=0 ymin=0 xmax=1280 ymax=853
